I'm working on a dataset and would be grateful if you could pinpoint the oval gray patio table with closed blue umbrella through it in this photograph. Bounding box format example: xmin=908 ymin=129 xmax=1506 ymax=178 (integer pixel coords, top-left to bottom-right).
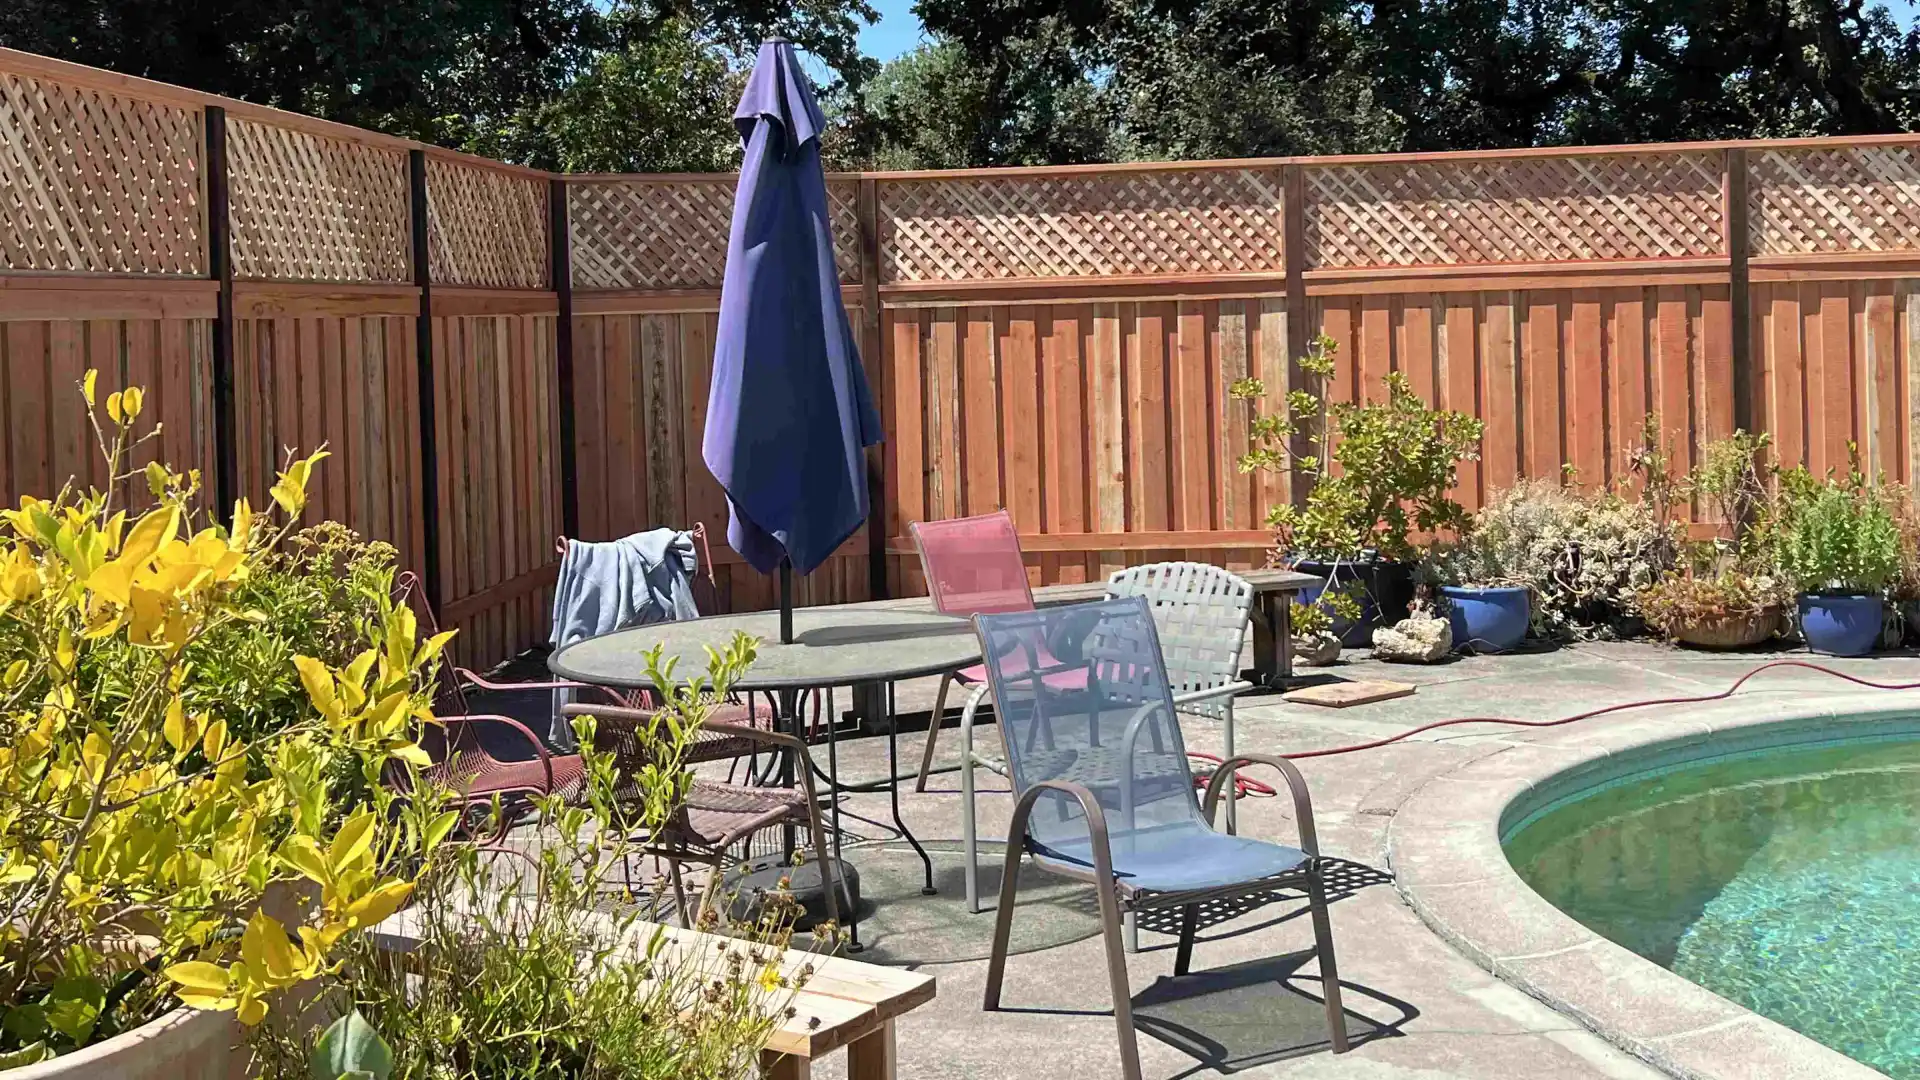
xmin=547 ymin=607 xmax=981 ymax=941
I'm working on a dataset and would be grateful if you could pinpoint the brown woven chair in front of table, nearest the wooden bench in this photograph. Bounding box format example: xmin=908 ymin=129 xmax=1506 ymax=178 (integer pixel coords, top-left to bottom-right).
xmin=561 ymin=703 xmax=851 ymax=926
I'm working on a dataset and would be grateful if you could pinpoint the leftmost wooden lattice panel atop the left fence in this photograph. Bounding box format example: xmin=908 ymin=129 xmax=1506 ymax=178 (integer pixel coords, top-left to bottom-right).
xmin=0 ymin=73 xmax=205 ymax=277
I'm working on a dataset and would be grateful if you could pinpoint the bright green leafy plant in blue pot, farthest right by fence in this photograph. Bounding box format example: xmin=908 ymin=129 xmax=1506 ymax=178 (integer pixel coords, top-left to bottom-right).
xmin=1774 ymin=469 xmax=1901 ymax=655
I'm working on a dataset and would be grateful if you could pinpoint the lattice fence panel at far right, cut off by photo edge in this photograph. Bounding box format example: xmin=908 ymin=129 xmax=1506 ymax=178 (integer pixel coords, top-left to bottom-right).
xmin=1747 ymin=146 xmax=1920 ymax=256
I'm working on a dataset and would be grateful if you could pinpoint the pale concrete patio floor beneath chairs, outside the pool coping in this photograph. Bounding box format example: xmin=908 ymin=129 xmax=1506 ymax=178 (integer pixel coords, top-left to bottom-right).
xmin=783 ymin=642 xmax=1920 ymax=1080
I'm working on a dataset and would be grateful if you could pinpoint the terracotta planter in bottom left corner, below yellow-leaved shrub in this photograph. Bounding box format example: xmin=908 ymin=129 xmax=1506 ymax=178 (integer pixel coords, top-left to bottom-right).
xmin=0 ymin=1009 xmax=250 ymax=1080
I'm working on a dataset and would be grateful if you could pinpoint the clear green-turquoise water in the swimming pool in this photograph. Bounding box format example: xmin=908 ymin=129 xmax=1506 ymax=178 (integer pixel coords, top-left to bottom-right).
xmin=1505 ymin=734 xmax=1920 ymax=1080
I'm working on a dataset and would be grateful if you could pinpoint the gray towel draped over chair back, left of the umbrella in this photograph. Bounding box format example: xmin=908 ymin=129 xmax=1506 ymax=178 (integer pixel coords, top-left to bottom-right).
xmin=549 ymin=528 xmax=701 ymax=749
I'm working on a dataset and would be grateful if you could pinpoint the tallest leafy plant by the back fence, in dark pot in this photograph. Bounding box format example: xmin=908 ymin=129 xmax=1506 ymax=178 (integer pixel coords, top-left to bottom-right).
xmin=1229 ymin=334 xmax=1482 ymax=644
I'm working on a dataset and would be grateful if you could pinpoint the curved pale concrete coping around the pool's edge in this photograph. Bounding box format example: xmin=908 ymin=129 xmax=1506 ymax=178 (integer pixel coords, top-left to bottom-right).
xmin=1386 ymin=692 xmax=1920 ymax=1080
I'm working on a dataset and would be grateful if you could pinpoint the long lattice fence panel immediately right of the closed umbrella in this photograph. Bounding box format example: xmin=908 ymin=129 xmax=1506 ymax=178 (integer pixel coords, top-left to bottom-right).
xmin=879 ymin=169 xmax=1286 ymax=282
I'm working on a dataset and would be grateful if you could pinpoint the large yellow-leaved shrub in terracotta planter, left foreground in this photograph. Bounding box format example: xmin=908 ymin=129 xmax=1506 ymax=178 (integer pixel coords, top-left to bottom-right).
xmin=0 ymin=373 xmax=439 ymax=1080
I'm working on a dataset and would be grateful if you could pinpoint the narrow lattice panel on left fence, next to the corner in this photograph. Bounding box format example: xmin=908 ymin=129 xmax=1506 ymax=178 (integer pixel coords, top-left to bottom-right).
xmin=426 ymin=156 xmax=549 ymax=288
